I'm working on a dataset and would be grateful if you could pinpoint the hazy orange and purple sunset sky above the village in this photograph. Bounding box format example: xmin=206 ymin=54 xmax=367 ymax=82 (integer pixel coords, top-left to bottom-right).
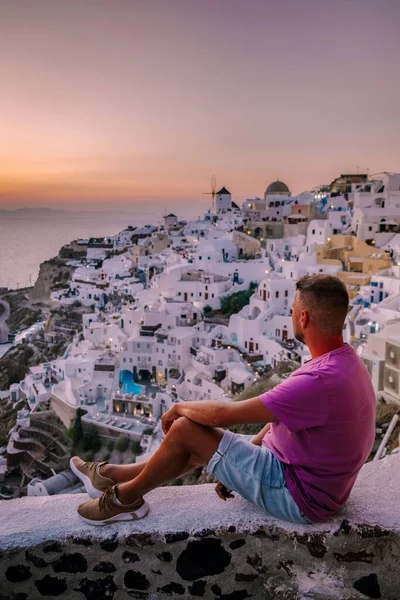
xmin=0 ymin=0 xmax=400 ymax=208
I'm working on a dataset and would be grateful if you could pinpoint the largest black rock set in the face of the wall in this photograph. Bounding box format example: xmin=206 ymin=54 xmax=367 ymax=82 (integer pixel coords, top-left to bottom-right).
xmin=176 ymin=538 xmax=231 ymax=581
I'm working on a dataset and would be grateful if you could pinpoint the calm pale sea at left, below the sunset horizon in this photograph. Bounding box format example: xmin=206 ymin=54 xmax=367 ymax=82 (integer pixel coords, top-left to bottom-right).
xmin=0 ymin=203 xmax=200 ymax=289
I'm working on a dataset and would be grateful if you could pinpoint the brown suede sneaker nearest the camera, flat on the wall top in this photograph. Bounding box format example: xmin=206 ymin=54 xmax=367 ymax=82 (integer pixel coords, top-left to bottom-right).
xmin=78 ymin=485 xmax=150 ymax=525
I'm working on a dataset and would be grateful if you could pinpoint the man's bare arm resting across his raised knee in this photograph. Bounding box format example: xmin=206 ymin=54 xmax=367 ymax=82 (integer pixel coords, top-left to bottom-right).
xmin=162 ymin=396 xmax=278 ymax=433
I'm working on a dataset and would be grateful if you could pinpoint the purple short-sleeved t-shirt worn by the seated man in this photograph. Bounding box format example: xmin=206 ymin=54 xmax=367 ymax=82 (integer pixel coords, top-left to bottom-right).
xmin=261 ymin=344 xmax=376 ymax=521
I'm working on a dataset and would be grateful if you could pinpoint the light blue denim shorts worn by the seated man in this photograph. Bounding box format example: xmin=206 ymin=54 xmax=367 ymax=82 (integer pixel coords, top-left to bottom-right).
xmin=206 ymin=431 xmax=312 ymax=524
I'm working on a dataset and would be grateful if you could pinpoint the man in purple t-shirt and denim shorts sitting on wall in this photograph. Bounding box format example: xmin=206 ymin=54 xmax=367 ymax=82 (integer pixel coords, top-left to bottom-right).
xmin=71 ymin=275 xmax=376 ymax=525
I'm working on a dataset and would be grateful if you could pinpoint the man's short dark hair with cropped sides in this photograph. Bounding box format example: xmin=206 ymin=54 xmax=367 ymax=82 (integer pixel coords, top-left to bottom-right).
xmin=296 ymin=275 xmax=349 ymax=335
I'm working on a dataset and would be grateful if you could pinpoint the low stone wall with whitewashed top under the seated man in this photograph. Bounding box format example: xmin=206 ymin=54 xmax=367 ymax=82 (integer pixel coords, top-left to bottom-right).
xmin=0 ymin=456 xmax=400 ymax=600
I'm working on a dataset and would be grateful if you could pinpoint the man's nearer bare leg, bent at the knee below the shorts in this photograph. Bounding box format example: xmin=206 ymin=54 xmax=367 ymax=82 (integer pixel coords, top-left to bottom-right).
xmin=118 ymin=417 xmax=224 ymax=504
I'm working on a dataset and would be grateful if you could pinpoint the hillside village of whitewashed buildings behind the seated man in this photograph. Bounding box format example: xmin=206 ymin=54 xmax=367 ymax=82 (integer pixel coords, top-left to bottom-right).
xmin=0 ymin=173 xmax=400 ymax=498
